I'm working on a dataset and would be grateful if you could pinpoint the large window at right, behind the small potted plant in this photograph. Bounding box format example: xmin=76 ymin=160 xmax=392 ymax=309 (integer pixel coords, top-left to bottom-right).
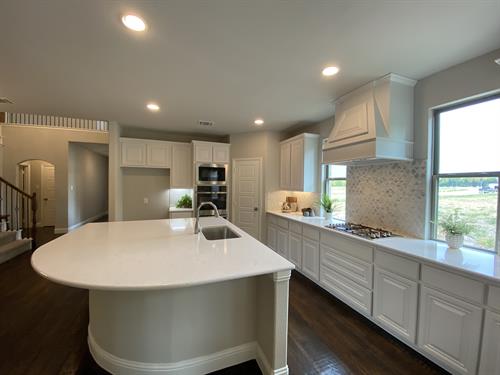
xmin=432 ymin=96 xmax=500 ymax=251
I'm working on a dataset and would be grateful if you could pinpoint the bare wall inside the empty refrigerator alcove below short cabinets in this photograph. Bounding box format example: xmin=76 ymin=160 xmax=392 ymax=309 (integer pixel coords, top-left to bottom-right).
xmin=122 ymin=168 xmax=170 ymax=220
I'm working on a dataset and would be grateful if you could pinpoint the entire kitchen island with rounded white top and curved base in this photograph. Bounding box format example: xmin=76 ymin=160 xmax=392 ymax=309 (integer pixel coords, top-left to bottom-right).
xmin=31 ymin=218 xmax=294 ymax=374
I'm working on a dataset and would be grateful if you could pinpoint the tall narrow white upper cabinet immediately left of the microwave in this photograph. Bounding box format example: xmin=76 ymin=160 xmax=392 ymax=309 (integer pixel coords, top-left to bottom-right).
xmin=170 ymin=143 xmax=193 ymax=189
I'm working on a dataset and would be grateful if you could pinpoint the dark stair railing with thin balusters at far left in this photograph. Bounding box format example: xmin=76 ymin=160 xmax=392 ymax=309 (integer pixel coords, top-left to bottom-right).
xmin=0 ymin=177 xmax=37 ymax=249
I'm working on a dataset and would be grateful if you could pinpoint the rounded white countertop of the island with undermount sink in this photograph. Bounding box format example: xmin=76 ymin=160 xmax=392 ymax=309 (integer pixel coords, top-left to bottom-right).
xmin=31 ymin=217 xmax=294 ymax=290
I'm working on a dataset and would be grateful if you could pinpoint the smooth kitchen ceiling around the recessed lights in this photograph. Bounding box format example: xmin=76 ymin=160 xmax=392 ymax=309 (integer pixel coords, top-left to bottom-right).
xmin=0 ymin=0 xmax=500 ymax=134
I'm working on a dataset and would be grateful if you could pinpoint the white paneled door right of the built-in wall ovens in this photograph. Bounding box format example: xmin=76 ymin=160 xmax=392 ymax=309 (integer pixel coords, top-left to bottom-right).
xmin=232 ymin=159 xmax=262 ymax=240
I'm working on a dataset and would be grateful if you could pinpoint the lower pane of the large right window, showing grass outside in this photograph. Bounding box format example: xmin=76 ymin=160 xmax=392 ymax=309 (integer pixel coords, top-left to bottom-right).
xmin=437 ymin=177 xmax=498 ymax=250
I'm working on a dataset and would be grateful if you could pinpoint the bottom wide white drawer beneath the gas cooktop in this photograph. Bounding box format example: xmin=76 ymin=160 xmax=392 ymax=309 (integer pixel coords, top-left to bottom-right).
xmin=320 ymin=266 xmax=372 ymax=316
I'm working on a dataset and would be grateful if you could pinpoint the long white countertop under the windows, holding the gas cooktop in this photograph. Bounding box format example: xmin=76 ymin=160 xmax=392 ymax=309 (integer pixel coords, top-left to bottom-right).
xmin=268 ymin=211 xmax=500 ymax=283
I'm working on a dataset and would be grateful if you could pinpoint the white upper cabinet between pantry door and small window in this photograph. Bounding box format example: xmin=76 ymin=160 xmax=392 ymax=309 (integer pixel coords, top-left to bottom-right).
xmin=280 ymin=133 xmax=319 ymax=192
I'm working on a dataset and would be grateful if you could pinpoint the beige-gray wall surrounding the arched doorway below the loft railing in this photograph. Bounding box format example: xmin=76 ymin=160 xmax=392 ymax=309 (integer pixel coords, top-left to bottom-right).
xmin=2 ymin=125 xmax=108 ymax=232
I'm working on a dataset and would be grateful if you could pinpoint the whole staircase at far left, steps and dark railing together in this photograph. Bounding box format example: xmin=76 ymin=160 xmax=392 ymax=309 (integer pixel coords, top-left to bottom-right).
xmin=0 ymin=177 xmax=37 ymax=264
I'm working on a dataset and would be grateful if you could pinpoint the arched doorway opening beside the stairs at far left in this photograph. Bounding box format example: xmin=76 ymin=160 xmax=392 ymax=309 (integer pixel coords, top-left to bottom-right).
xmin=16 ymin=159 xmax=56 ymax=231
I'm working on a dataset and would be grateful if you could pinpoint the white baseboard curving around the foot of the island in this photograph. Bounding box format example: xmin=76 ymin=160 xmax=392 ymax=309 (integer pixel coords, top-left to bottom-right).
xmin=88 ymin=327 xmax=268 ymax=375
